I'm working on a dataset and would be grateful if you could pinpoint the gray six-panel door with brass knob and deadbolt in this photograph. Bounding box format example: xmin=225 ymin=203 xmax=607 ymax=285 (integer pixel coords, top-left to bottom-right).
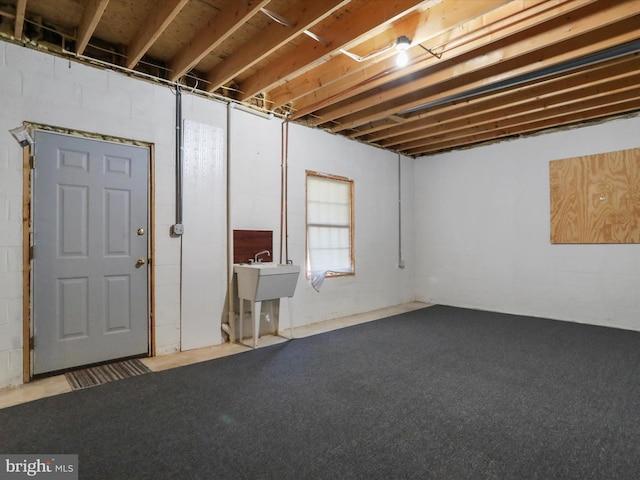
xmin=32 ymin=131 xmax=149 ymax=374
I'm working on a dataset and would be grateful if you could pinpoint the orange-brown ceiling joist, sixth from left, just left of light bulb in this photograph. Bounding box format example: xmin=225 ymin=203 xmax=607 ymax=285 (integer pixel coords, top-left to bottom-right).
xmin=238 ymin=0 xmax=422 ymax=100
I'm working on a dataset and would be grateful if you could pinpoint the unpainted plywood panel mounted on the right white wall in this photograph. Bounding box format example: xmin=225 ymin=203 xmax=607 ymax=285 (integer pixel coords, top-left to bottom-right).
xmin=549 ymin=148 xmax=640 ymax=243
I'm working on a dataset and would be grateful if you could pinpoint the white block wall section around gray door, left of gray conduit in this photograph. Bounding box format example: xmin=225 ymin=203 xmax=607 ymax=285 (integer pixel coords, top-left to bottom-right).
xmin=0 ymin=42 xmax=185 ymax=386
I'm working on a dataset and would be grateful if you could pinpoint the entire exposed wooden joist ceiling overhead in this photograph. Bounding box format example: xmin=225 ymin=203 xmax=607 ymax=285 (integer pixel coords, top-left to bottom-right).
xmin=6 ymin=0 xmax=640 ymax=157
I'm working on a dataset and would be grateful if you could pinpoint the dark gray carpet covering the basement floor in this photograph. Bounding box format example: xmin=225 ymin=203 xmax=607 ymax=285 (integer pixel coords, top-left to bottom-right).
xmin=0 ymin=306 xmax=640 ymax=480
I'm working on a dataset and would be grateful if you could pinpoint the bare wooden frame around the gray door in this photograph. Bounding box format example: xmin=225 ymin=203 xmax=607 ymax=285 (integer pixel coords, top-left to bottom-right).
xmin=22 ymin=121 xmax=156 ymax=383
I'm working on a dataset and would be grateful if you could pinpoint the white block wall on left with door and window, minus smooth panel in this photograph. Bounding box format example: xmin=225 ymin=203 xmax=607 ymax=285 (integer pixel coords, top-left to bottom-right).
xmin=0 ymin=41 xmax=415 ymax=387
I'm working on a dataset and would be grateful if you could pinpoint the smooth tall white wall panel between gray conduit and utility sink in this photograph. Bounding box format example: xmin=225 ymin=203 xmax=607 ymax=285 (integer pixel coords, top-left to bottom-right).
xmin=181 ymin=120 xmax=227 ymax=350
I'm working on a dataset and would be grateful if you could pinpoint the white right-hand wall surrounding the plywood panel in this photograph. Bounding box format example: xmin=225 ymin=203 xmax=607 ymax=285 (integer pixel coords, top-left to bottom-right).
xmin=415 ymin=117 xmax=640 ymax=330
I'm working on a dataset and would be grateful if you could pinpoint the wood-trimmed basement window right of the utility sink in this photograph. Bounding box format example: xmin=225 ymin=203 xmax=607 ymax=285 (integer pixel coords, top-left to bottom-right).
xmin=307 ymin=171 xmax=354 ymax=278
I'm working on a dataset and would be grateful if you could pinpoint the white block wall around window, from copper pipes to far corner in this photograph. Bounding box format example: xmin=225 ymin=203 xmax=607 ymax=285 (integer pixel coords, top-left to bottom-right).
xmin=289 ymin=125 xmax=415 ymax=324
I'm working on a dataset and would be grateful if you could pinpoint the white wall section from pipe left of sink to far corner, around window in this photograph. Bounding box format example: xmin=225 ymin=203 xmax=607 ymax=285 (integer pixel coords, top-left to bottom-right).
xmin=229 ymin=109 xmax=415 ymax=328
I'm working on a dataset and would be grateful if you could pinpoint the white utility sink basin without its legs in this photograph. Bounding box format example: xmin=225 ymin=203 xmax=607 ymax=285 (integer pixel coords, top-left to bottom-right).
xmin=233 ymin=263 xmax=300 ymax=302
